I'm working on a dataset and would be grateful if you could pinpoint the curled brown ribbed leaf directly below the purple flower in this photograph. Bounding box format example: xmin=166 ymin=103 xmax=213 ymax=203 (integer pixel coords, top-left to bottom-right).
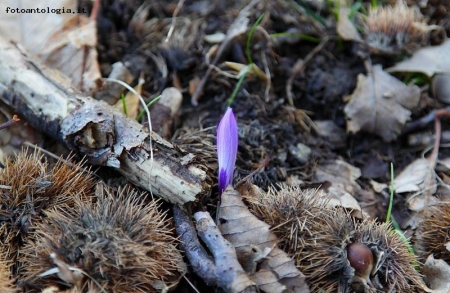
xmin=219 ymin=187 xmax=309 ymax=293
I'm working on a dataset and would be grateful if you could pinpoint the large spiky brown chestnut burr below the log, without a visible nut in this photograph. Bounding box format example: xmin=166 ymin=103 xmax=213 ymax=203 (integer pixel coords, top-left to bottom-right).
xmin=20 ymin=184 xmax=184 ymax=292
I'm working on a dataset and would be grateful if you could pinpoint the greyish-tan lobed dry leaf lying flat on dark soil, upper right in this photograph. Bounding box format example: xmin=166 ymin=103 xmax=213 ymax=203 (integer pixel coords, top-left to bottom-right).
xmin=344 ymin=65 xmax=420 ymax=142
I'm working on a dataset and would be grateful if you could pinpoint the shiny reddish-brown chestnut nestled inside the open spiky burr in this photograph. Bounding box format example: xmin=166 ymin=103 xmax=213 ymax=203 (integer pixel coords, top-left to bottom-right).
xmin=347 ymin=242 xmax=373 ymax=280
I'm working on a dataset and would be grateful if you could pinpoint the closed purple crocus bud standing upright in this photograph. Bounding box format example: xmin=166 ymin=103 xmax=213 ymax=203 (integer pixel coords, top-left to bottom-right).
xmin=217 ymin=108 xmax=238 ymax=194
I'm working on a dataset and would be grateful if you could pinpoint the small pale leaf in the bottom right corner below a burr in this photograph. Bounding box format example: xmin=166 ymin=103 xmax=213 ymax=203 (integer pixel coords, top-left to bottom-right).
xmin=421 ymin=255 xmax=450 ymax=293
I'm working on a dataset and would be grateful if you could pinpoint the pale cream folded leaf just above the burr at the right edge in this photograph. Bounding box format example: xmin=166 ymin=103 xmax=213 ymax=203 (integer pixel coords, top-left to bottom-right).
xmin=394 ymin=158 xmax=437 ymax=211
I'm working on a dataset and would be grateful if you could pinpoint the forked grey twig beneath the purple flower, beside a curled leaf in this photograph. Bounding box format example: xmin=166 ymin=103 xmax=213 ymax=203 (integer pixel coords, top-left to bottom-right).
xmin=173 ymin=205 xmax=256 ymax=292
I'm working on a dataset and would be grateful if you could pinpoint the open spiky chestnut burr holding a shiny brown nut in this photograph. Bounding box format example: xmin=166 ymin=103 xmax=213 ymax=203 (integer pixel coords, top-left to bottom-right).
xmin=246 ymin=187 xmax=421 ymax=292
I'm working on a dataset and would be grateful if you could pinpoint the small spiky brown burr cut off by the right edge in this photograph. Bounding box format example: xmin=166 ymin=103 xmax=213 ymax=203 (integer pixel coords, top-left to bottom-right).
xmin=415 ymin=204 xmax=450 ymax=264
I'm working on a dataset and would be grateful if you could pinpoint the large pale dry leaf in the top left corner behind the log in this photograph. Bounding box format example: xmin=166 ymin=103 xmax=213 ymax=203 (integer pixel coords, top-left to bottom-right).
xmin=0 ymin=0 xmax=101 ymax=94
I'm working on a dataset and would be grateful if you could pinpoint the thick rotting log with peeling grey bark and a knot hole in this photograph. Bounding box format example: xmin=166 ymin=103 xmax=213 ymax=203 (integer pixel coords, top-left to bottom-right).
xmin=0 ymin=37 xmax=211 ymax=204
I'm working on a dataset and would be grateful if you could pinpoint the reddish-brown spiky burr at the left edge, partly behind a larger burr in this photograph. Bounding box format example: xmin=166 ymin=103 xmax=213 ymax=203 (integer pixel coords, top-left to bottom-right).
xmin=0 ymin=151 xmax=94 ymax=272
